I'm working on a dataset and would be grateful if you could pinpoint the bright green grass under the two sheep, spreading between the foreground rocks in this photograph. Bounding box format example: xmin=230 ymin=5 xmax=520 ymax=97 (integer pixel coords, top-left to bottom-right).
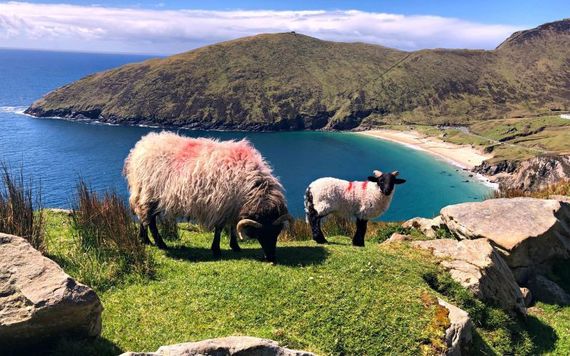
xmin=36 ymin=213 xmax=570 ymax=355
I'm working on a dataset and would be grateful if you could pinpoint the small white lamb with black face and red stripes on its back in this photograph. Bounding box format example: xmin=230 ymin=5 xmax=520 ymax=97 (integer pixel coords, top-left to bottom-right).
xmin=305 ymin=170 xmax=406 ymax=246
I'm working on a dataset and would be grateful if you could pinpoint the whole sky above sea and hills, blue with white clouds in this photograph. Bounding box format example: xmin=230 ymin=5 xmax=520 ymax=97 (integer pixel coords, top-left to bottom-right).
xmin=0 ymin=0 xmax=570 ymax=55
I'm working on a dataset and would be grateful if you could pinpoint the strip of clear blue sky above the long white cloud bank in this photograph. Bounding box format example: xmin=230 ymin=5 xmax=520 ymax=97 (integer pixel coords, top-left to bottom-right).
xmin=20 ymin=0 xmax=570 ymax=26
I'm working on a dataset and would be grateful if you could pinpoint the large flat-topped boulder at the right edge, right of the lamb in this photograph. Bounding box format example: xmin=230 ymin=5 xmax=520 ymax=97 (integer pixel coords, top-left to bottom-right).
xmin=441 ymin=198 xmax=570 ymax=272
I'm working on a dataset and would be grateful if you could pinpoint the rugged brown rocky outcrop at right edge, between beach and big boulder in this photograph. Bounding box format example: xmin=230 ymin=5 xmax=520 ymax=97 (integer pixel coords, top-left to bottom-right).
xmin=474 ymin=155 xmax=570 ymax=191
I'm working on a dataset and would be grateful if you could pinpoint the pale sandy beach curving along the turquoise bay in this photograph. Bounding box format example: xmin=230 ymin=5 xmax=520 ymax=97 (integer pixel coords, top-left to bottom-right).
xmin=359 ymin=129 xmax=492 ymax=169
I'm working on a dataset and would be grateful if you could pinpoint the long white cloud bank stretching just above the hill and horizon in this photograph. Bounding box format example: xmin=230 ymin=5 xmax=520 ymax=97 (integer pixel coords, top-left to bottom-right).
xmin=0 ymin=2 xmax=521 ymax=54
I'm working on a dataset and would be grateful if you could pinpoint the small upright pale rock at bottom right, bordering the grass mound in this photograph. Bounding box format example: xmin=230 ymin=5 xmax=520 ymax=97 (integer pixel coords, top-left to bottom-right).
xmin=437 ymin=298 xmax=473 ymax=356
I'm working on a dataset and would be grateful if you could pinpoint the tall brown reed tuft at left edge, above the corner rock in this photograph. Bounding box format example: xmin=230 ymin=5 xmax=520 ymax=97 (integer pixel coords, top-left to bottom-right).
xmin=0 ymin=164 xmax=45 ymax=252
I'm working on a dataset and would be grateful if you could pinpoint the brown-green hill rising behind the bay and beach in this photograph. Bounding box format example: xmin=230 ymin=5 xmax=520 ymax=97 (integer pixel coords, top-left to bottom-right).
xmin=27 ymin=19 xmax=570 ymax=130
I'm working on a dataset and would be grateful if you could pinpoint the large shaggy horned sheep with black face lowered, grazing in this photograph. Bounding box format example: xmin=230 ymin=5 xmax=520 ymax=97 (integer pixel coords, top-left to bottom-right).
xmin=123 ymin=131 xmax=292 ymax=262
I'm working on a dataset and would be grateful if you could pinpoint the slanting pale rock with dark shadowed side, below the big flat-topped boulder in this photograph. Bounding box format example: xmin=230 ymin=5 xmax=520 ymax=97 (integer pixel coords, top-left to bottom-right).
xmin=412 ymin=239 xmax=526 ymax=313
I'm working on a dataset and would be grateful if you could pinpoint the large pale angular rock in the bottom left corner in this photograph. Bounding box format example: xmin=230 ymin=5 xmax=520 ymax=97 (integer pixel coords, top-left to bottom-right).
xmin=0 ymin=233 xmax=103 ymax=346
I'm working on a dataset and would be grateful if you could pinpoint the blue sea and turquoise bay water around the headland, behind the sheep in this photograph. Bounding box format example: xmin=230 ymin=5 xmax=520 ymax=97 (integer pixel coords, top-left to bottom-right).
xmin=0 ymin=50 xmax=489 ymax=220
